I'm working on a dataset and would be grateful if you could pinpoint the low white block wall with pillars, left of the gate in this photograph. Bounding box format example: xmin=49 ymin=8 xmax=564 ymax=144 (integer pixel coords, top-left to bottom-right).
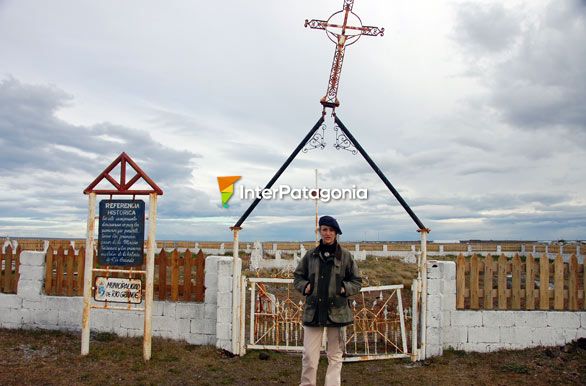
xmin=0 ymin=251 xmax=240 ymax=348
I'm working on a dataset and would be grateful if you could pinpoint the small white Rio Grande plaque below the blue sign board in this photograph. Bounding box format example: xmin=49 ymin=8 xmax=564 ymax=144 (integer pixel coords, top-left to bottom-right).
xmin=94 ymin=276 xmax=142 ymax=304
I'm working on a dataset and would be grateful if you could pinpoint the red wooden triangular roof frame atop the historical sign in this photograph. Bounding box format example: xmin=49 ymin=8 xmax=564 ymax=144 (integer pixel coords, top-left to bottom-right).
xmin=83 ymin=152 xmax=163 ymax=195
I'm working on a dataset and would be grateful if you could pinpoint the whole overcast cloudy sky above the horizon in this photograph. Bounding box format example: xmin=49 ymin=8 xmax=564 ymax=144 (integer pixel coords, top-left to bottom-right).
xmin=0 ymin=0 xmax=586 ymax=240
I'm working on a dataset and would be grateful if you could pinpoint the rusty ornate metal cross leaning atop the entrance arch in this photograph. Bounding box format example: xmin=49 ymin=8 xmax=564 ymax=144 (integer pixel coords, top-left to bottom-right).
xmin=305 ymin=0 xmax=385 ymax=113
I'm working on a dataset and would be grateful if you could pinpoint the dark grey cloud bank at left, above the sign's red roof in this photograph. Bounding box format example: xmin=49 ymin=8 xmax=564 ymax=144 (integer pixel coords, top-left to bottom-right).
xmin=0 ymin=78 xmax=199 ymax=183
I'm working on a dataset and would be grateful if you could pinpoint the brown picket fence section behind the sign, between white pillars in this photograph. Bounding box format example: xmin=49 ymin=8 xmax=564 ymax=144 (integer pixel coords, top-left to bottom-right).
xmin=45 ymin=246 xmax=205 ymax=302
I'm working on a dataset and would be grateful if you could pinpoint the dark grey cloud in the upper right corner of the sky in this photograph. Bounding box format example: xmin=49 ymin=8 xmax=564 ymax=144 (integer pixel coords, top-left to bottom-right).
xmin=456 ymin=0 xmax=586 ymax=131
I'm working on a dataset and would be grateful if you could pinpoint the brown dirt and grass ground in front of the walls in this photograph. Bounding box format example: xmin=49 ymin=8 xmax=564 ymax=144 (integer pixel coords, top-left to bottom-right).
xmin=0 ymin=329 xmax=586 ymax=386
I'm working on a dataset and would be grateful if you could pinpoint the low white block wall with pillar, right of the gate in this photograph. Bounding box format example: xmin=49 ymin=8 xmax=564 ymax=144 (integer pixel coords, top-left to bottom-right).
xmin=426 ymin=260 xmax=586 ymax=357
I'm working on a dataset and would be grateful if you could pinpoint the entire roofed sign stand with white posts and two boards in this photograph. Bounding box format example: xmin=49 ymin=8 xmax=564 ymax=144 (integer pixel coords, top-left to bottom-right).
xmin=81 ymin=153 xmax=163 ymax=361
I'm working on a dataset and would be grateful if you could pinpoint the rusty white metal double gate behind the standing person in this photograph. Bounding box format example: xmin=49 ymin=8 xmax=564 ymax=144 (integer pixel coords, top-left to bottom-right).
xmin=241 ymin=277 xmax=412 ymax=362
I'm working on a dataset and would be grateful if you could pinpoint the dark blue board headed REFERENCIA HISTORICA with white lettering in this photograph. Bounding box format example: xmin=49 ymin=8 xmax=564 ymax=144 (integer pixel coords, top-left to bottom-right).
xmin=98 ymin=200 xmax=145 ymax=266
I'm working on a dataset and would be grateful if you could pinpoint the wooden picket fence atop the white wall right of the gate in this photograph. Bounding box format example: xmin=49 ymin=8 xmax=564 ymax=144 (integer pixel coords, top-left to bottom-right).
xmin=456 ymin=254 xmax=586 ymax=311
